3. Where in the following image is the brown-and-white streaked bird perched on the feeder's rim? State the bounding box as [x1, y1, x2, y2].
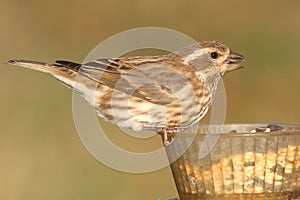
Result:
[8, 41, 245, 146]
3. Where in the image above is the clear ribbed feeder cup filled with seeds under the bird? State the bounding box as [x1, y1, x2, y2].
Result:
[166, 124, 300, 200]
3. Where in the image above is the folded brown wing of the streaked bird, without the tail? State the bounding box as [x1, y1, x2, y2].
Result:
[70, 56, 191, 105]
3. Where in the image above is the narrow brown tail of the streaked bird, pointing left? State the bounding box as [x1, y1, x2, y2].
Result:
[8, 59, 81, 87]
